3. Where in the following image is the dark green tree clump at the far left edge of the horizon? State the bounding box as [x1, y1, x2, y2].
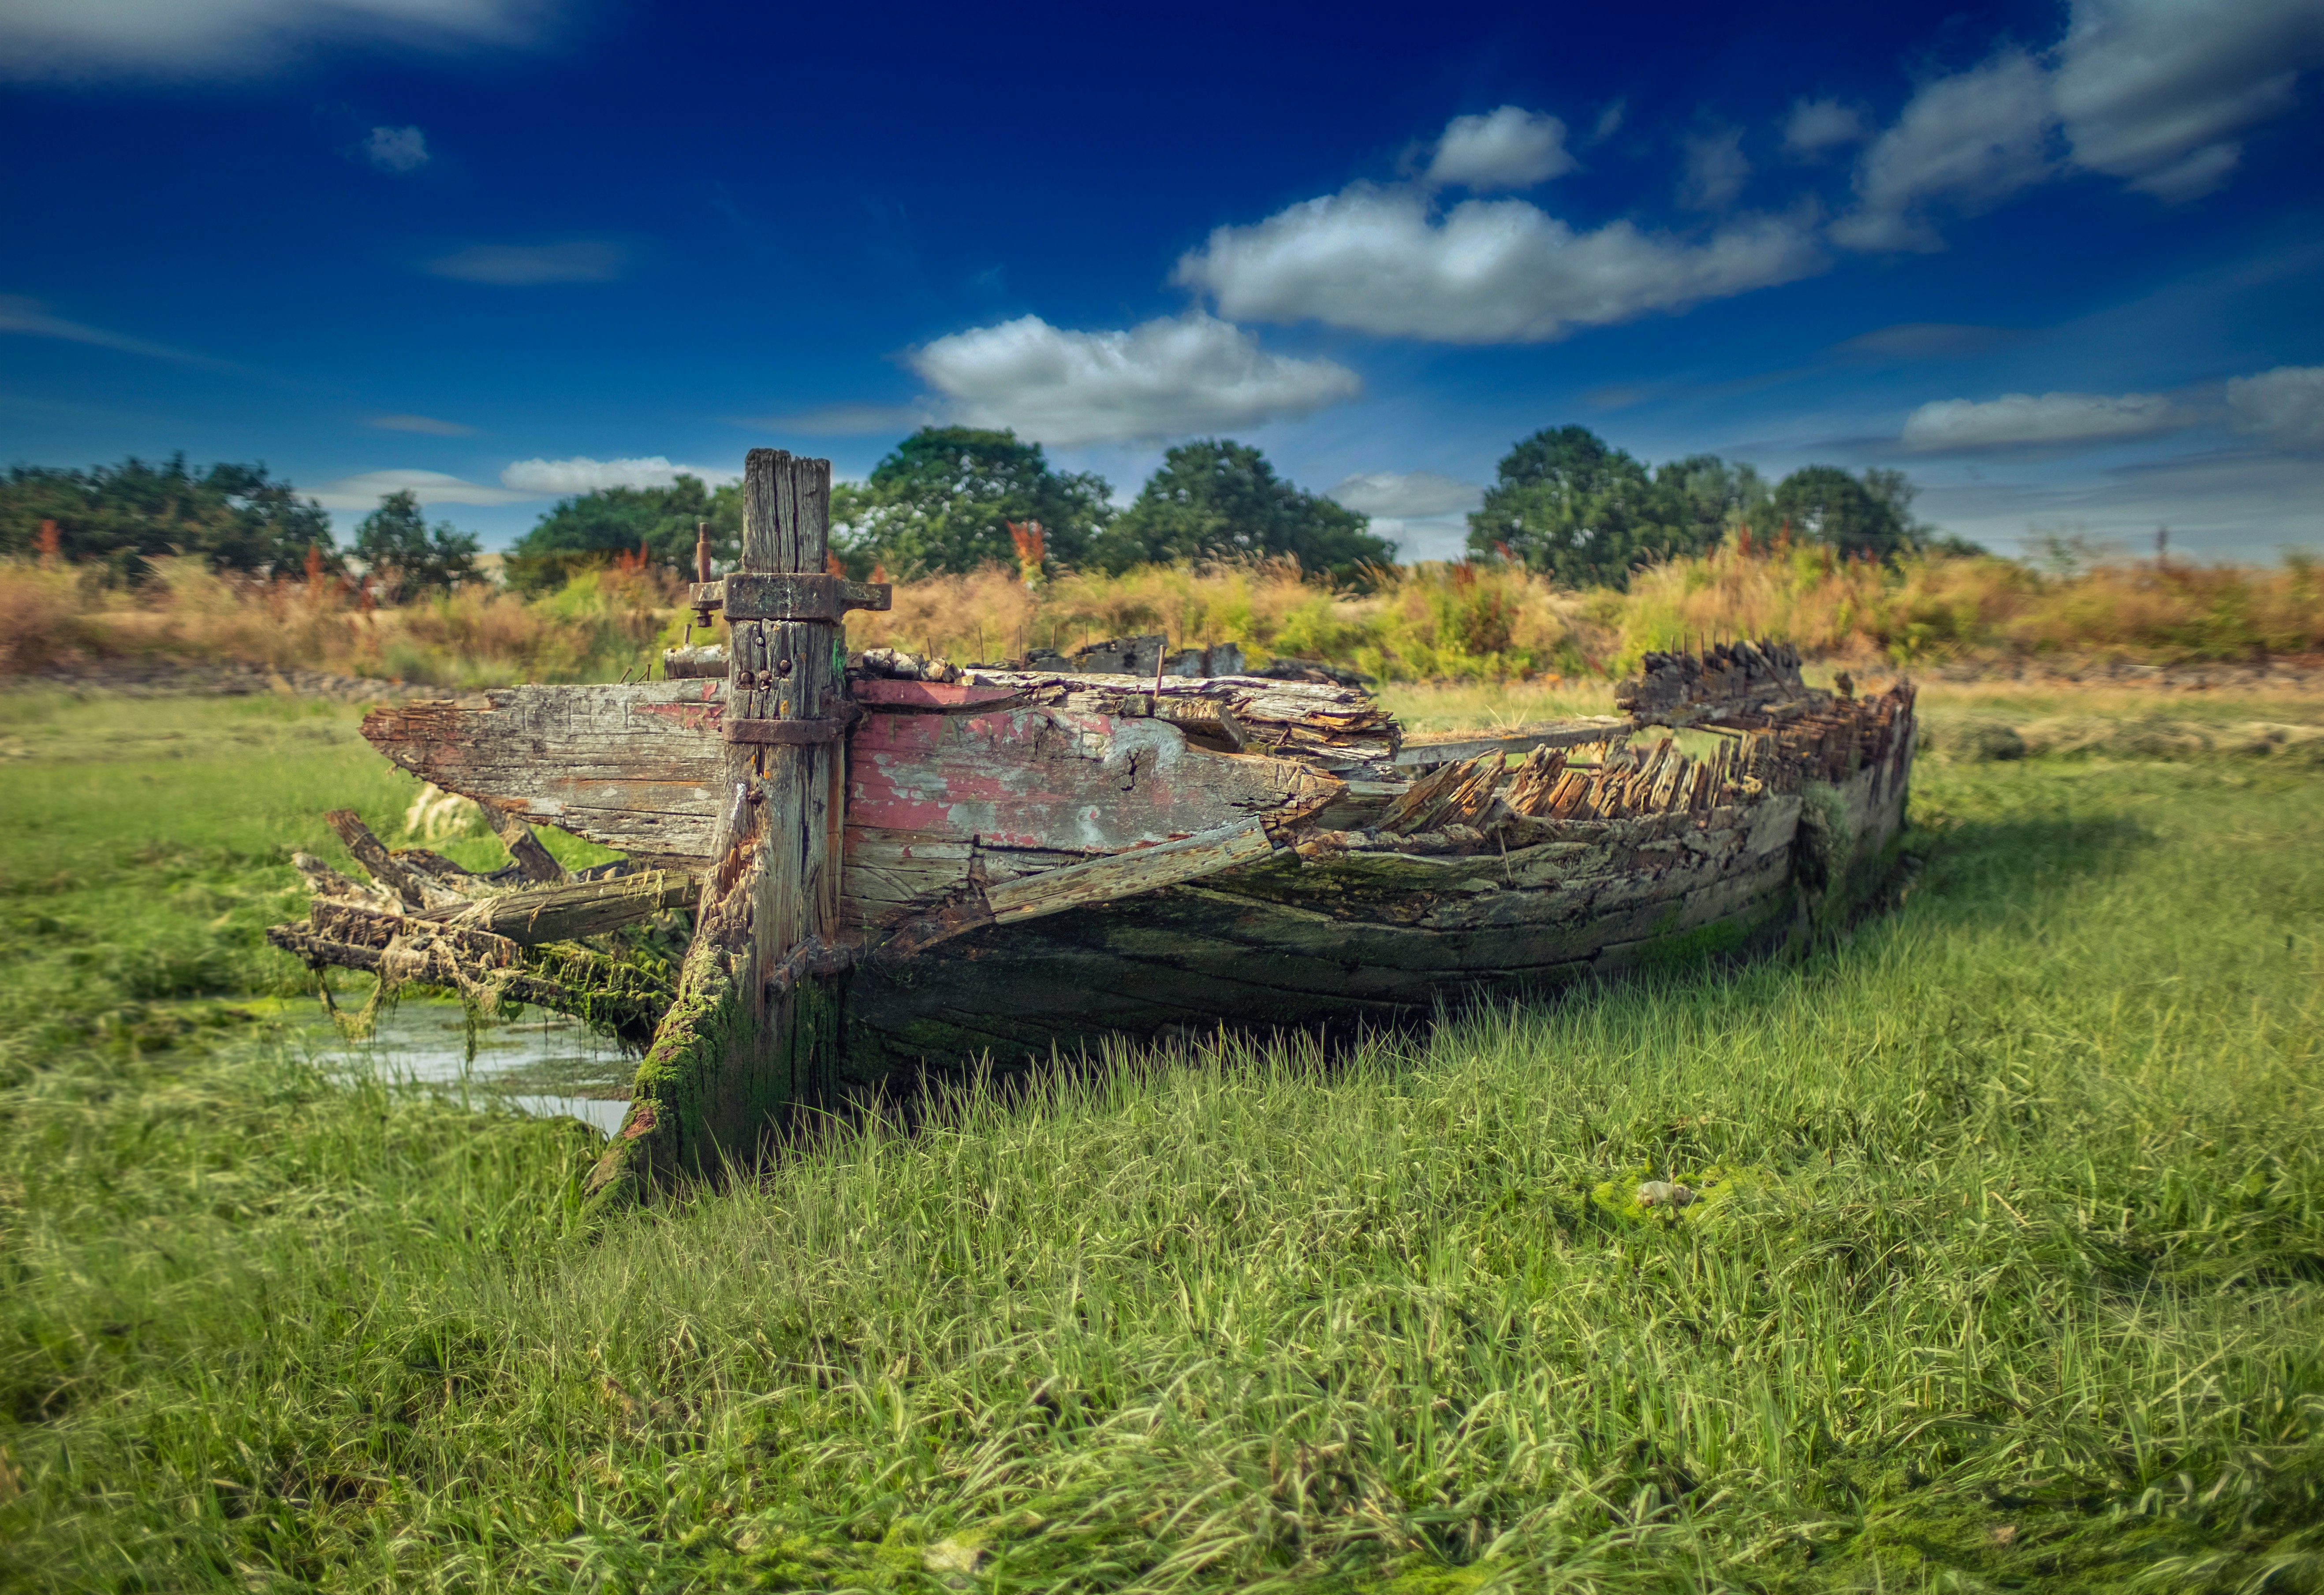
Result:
[0, 453, 339, 581]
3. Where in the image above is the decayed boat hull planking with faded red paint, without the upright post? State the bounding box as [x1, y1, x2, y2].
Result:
[299, 648, 1913, 1125]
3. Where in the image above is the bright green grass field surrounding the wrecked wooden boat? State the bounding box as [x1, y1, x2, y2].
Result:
[0, 688, 2324, 1595]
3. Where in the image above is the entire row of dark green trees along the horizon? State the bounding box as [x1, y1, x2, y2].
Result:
[0, 425, 1966, 602]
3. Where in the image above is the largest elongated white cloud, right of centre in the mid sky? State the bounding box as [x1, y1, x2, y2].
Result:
[1176, 184, 1824, 344]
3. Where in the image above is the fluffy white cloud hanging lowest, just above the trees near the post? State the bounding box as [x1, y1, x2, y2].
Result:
[911, 312, 1364, 447]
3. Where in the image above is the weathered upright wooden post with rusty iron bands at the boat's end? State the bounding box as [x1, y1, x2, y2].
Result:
[590, 449, 888, 1195]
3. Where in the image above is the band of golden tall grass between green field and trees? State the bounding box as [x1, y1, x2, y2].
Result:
[0, 540, 2324, 688]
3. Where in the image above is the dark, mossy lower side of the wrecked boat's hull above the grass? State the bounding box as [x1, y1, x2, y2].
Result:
[841, 732, 1913, 1086]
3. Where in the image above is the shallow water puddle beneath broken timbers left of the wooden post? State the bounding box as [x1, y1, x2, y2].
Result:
[316, 1000, 637, 1135]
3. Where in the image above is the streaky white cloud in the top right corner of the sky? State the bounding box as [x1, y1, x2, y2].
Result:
[2052, 0, 2324, 200]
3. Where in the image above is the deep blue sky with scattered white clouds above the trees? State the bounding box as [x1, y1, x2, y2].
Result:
[0, 0, 2324, 558]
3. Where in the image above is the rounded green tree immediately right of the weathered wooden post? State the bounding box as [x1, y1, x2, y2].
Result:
[832, 425, 1113, 577]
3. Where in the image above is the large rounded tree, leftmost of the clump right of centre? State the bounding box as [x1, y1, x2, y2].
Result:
[1469, 425, 1690, 586]
